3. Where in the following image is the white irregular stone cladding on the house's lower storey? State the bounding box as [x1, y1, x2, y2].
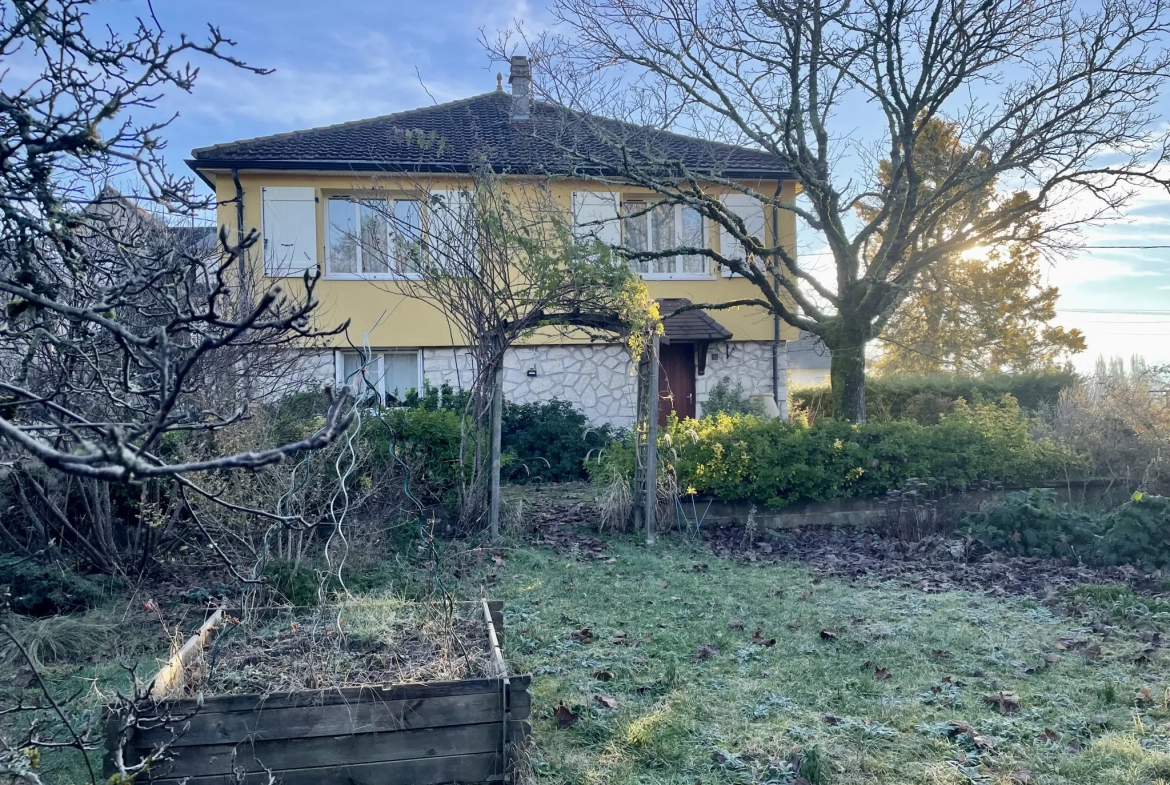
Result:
[293, 340, 787, 428]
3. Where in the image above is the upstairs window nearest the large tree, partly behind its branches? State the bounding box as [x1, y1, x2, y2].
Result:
[621, 200, 710, 278]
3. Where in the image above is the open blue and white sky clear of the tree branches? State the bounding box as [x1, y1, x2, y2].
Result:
[88, 0, 1170, 369]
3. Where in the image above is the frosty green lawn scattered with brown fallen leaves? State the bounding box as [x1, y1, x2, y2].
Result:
[466, 540, 1170, 785]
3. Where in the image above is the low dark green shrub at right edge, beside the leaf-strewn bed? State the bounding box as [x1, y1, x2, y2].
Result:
[964, 489, 1170, 570]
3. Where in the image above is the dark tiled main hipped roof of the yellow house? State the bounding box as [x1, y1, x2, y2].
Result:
[187, 90, 787, 179]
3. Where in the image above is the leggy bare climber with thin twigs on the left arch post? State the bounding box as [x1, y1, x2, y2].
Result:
[352, 164, 660, 536]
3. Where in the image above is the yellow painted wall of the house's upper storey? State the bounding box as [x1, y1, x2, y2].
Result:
[200, 170, 798, 349]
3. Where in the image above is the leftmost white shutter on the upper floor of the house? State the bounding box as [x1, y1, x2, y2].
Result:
[260, 187, 317, 277]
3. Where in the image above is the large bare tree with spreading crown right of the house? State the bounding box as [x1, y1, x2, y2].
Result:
[489, 0, 1170, 421]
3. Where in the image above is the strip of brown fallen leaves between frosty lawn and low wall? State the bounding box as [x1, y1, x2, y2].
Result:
[703, 526, 1162, 600]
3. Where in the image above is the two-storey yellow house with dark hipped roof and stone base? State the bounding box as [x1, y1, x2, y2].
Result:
[187, 57, 798, 426]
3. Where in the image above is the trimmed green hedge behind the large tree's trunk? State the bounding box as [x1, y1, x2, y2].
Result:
[789, 371, 1076, 425]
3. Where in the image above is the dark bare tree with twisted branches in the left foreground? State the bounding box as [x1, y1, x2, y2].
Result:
[0, 0, 349, 488]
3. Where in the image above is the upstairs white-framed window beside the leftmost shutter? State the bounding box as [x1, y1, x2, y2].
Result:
[326, 197, 422, 278]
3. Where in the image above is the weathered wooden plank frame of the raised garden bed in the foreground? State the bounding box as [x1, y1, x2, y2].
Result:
[105, 600, 531, 785]
